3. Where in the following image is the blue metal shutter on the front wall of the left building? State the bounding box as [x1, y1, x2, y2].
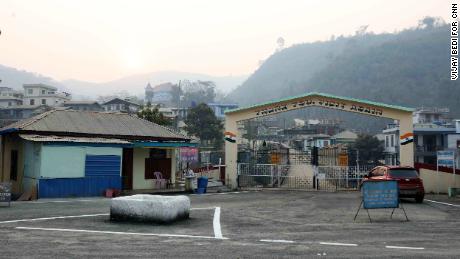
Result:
[85, 155, 121, 177]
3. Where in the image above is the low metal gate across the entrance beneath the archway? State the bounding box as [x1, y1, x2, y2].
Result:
[238, 163, 373, 191]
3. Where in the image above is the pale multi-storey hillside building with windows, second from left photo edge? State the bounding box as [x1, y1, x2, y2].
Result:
[23, 84, 72, 107]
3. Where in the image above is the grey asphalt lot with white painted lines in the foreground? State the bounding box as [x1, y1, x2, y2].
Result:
[0, 191, 460, 258]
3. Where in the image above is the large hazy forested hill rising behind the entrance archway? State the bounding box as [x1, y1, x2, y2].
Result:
[229, 20, 460, 120]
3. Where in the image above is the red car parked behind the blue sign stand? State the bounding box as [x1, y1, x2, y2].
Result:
[363, 165, 425, 203]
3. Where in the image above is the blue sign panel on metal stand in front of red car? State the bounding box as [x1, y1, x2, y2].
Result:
[362, 180, 399, 209]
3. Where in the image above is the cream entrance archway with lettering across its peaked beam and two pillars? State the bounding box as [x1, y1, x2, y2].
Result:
[225, 93, 414, 188]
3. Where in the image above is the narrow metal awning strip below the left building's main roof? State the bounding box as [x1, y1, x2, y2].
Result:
[19, 134, 131, 144]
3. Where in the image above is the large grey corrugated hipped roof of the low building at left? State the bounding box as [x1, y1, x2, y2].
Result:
[0, 110, 190, 140]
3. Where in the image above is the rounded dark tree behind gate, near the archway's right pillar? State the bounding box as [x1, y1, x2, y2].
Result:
[352, 134, 384, 164]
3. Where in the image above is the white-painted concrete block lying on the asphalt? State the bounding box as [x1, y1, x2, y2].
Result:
[110, 194, 190, 223]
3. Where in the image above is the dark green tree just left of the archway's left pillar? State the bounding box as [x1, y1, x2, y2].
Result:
[185, 103, 224, 148]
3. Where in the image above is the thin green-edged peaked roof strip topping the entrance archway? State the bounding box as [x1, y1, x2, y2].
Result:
[225, 92, 415, 114]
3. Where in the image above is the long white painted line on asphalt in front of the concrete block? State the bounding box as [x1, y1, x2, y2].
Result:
[16, 227, 228, 242]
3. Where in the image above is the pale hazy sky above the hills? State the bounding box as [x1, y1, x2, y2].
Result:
[0, 0, 451, 82]
